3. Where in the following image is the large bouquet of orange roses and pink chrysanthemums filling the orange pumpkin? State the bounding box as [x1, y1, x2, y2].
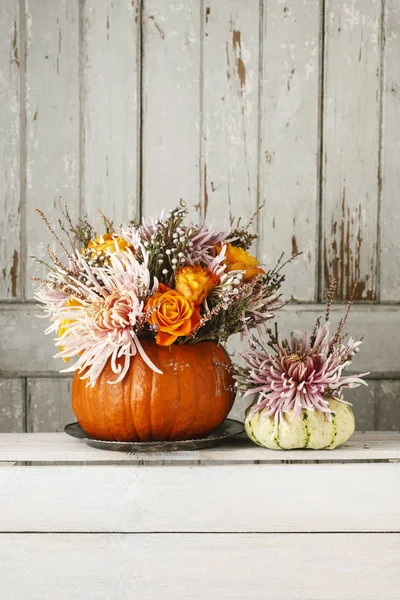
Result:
[35, 203, 284, 385]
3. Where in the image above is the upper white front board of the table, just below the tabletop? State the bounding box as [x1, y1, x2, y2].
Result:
[0, 462, 400, 533]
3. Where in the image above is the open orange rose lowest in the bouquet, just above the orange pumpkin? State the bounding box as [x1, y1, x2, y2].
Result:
[145, 284, 201, 346]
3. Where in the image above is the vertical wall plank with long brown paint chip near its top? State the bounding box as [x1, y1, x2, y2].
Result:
[201, 0, 260, 227]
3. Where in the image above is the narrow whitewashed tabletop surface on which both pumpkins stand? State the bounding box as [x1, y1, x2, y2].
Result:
[0, 431, 400, 466]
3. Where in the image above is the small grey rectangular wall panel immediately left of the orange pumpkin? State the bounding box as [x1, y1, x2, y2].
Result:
[27, 378, 76, 433]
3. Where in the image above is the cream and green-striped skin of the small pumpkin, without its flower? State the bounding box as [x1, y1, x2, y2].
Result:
[245, 398, 355, 450]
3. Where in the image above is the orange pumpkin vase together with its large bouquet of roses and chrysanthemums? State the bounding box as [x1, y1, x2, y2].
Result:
[35, 203, 283, 442]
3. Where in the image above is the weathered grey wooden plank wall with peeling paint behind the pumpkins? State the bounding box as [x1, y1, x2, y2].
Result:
[0, 0, 400, 431]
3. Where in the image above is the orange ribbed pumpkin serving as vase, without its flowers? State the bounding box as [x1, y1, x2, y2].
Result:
[72, 340, 235, 442]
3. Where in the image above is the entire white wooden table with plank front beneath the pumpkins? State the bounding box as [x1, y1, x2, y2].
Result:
[0, 432, 400, 600]
